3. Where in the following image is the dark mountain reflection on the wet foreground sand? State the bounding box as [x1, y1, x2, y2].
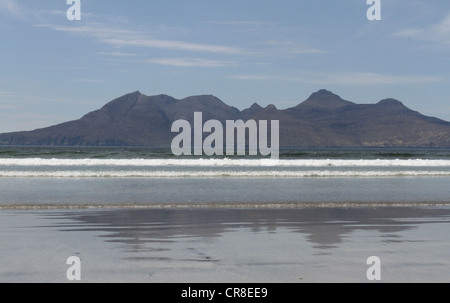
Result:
[46, 207, 450, 255]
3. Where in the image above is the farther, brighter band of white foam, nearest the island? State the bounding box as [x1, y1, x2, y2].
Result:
[0, 158, 450, 167]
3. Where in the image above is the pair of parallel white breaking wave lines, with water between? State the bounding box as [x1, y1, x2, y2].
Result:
[0, 158, 450, 178]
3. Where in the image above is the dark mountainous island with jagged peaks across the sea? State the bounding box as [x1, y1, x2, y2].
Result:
[0, 90, 450, 148]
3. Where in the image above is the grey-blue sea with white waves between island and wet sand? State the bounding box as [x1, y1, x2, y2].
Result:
[0, 147, 450, 209]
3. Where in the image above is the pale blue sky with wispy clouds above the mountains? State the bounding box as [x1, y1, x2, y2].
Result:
[0, 0, 450, 133]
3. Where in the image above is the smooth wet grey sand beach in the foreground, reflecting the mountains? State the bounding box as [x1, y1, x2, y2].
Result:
[0, 206, 450, 283]
